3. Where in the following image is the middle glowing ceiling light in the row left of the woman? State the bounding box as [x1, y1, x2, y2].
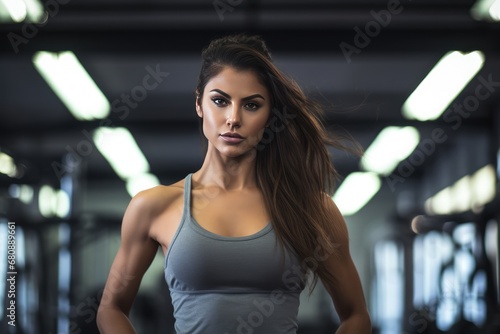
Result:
[93, 127, 149, 180]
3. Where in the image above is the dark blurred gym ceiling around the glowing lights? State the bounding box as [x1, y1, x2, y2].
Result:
[0, 0, 500, 217]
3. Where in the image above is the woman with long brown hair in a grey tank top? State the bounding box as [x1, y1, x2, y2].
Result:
[97, 35, 371, 334]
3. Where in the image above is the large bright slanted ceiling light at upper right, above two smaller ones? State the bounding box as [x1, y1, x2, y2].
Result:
[402, 51, 484, 121]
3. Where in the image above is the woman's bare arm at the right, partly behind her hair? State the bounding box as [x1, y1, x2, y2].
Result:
[323, 197, 372, 334]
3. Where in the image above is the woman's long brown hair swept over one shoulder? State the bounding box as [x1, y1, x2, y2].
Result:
[196, 34, 360, 289]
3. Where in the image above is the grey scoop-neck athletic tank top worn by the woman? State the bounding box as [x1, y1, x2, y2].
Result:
[165, 174, 305, 334]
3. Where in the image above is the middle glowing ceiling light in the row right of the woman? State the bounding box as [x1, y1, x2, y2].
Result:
[361, 126, 420, 175]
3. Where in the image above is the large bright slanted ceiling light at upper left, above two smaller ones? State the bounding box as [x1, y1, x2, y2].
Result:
[33, 51, 111, 120]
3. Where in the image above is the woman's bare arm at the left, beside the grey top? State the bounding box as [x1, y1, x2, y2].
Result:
[97, 191, 158, 334]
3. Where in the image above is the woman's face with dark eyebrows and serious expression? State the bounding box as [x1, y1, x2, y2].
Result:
[196, 67, 271, 157]
